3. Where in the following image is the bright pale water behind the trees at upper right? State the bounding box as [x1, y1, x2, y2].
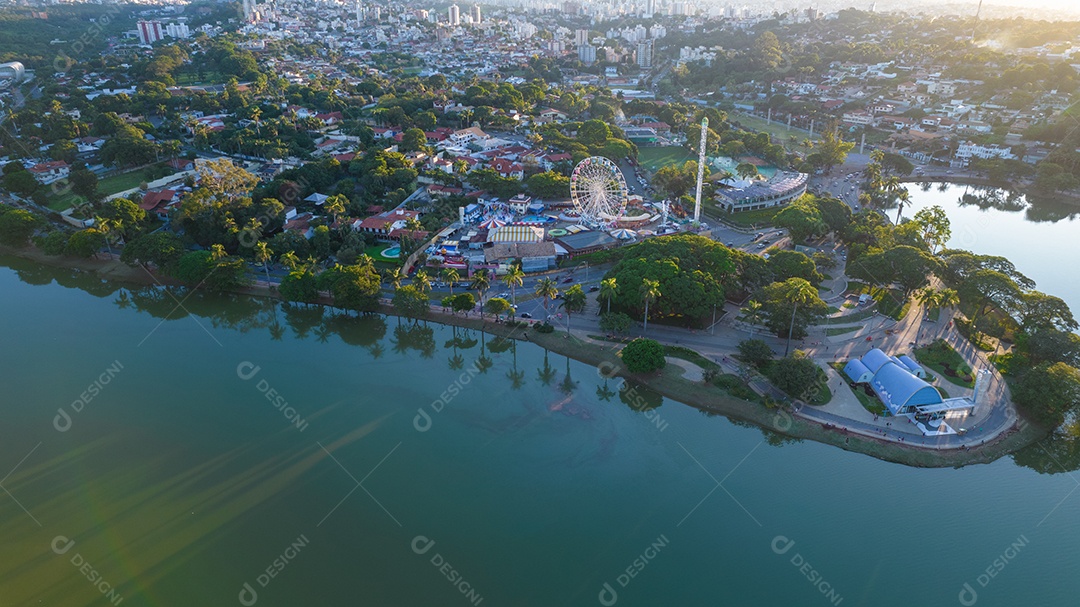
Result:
[890, 184, 1080, 312]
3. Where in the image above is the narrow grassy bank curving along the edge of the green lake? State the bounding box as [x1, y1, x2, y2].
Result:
[0, 241, 1045, 468]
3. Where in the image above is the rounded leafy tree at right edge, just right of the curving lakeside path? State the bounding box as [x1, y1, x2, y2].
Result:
[1012, 363, 1080, 428]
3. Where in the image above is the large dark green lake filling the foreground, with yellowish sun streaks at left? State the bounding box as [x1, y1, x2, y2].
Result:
[0, 258, 1080, 607]
